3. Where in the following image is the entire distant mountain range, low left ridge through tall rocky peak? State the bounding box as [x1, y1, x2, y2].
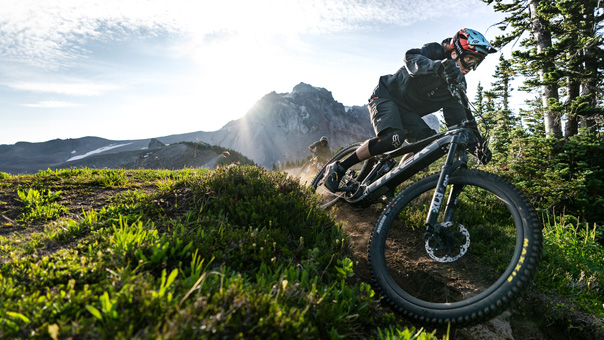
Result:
[0, 83, 438, 174]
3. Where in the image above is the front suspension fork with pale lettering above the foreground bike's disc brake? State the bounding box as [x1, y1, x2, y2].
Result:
[426, 136, 463, 229]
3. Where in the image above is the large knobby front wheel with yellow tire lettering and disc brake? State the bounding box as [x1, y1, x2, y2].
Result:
[369, 169, 542, 326]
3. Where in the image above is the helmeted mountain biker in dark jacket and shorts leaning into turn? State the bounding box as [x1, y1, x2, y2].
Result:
[324, 28, 497, 192]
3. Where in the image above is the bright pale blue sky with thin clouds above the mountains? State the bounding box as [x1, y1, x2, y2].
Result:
[0, 0, 520, 144]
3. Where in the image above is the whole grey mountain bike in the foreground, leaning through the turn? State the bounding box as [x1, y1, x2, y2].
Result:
[311, 80, 543, 326]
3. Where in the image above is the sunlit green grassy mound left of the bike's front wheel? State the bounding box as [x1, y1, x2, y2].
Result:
[0, 166, 444, 339]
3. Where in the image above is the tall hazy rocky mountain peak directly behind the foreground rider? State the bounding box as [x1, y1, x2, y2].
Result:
[189, 83, 373, 168]
